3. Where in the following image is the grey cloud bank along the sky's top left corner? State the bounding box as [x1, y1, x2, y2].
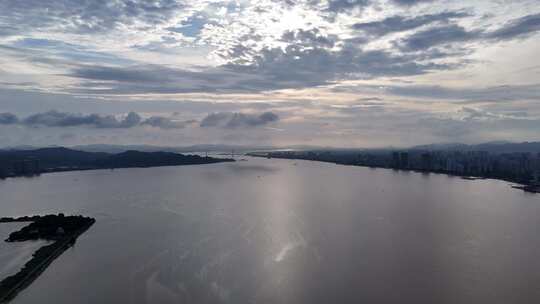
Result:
[0, 0, 184, 33]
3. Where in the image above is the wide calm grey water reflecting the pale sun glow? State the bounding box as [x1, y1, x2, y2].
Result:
[0, 158, 540, 304]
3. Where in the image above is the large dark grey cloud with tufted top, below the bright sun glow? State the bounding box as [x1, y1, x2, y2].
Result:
[216, 29, 460, 90]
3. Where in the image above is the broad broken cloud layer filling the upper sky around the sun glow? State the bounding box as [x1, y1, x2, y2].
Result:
[0, 0, 538, 95]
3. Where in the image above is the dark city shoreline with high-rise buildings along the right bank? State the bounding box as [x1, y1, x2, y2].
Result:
[267, 150, 540, 187]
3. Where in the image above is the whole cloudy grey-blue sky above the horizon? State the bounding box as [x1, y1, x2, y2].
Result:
[0, 0, 540, 147]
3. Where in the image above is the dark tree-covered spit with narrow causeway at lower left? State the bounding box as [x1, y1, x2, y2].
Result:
[0, 213, 96, 303]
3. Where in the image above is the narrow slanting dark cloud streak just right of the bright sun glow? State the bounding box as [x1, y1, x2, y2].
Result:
[352, 12, 470, 36]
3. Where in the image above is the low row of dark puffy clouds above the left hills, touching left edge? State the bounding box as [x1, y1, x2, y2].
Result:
[0, 111, 184, 129]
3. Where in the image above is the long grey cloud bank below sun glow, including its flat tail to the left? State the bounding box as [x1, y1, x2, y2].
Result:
[67, 38, 453, 94]
